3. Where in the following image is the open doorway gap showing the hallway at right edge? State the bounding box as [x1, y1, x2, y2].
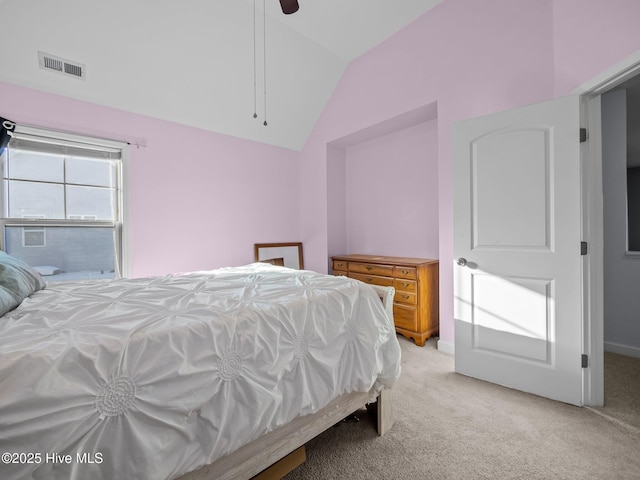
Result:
[601, 75, 640, 428]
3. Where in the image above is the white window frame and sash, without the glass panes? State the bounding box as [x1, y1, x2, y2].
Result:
[0, 125, 129, 278]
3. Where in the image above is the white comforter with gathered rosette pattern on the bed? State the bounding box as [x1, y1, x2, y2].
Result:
[0, 264, 400, 480]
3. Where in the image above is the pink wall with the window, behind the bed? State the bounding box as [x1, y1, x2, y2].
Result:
[0, 82, 300, 276]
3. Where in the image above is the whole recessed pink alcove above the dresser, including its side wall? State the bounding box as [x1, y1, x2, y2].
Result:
[327, 102, 438, 270]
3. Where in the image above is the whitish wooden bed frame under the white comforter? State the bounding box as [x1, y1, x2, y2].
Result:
[178, 285, 395, 480]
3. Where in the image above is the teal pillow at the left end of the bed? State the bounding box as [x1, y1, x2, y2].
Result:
[0, 251, 46, 315]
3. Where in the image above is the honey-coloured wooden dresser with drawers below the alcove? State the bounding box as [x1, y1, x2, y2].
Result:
[331, 255, 439, 346]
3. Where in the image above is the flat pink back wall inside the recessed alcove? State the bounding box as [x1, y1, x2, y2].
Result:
[342, 120, 439, 258]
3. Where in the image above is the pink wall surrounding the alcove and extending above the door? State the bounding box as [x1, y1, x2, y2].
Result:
[301, 0, 640, 345]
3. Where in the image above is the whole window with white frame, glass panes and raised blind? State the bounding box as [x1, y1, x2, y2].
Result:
[0, 126, 127, 281]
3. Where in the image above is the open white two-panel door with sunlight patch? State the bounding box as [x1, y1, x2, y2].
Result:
[453, 96, 582, 405]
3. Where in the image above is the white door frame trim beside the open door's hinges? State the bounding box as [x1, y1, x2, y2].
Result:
[572, 50, 640, 406]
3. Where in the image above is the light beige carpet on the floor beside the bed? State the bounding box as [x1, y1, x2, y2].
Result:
[284, 337, 640, 480]
